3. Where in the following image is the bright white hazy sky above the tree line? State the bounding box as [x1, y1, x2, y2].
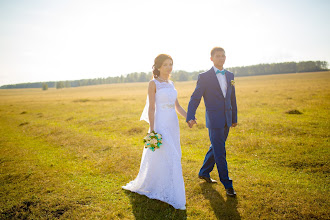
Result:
[0, 0, 330, 86]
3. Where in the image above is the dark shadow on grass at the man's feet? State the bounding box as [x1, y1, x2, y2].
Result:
[200, 182, 241, 220]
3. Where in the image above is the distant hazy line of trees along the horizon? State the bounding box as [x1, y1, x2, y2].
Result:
[0, 61, 328, 90]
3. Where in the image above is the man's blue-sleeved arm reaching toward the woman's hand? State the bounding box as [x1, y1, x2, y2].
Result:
[186, 74, 205, 122]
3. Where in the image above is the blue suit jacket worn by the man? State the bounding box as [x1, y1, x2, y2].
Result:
[187, 67, 237, 128]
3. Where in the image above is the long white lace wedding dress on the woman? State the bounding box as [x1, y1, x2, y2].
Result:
[123, 79, 186, 210]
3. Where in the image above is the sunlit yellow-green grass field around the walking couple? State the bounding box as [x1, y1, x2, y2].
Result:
[0, 72, 330, 219]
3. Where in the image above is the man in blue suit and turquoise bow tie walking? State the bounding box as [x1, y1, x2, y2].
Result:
[187, 47, 237, 196]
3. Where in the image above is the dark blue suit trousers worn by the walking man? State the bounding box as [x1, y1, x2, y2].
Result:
[199, 126, 233, 189]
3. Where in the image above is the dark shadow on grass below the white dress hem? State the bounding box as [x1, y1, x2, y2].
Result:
[124, 190, 187, 220]
